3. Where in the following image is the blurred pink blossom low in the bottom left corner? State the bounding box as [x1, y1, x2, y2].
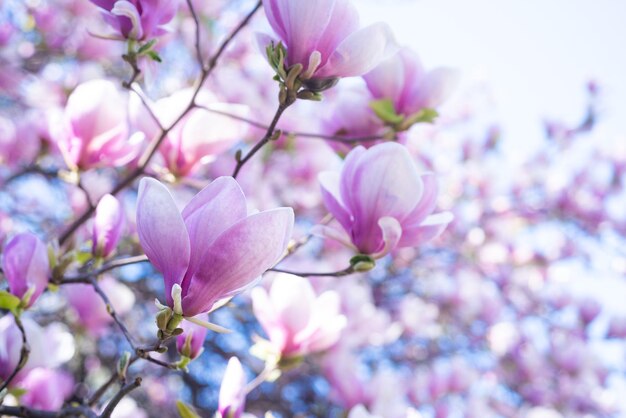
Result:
[17, 367, 74, 411]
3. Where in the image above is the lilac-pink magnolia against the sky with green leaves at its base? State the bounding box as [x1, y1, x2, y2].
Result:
[363, 47, 457, 116]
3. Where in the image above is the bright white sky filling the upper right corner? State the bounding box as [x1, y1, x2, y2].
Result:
[357, 0, 626, 159]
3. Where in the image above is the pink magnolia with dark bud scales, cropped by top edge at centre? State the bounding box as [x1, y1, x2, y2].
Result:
[263, 0, 395, 88]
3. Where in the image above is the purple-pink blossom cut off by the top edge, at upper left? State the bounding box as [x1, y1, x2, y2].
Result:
[91, 0, 180, 41]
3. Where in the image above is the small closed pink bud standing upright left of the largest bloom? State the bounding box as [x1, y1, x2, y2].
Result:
[92, 194, 124, 257]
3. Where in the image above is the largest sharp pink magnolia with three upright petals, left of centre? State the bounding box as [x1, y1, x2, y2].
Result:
[137, 177, 294, 320]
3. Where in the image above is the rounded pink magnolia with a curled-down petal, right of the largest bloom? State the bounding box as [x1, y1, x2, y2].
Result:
[319, 142, 452, 258]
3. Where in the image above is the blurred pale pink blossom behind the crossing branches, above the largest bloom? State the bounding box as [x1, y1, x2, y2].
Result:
[131, 89, 248, 177]
